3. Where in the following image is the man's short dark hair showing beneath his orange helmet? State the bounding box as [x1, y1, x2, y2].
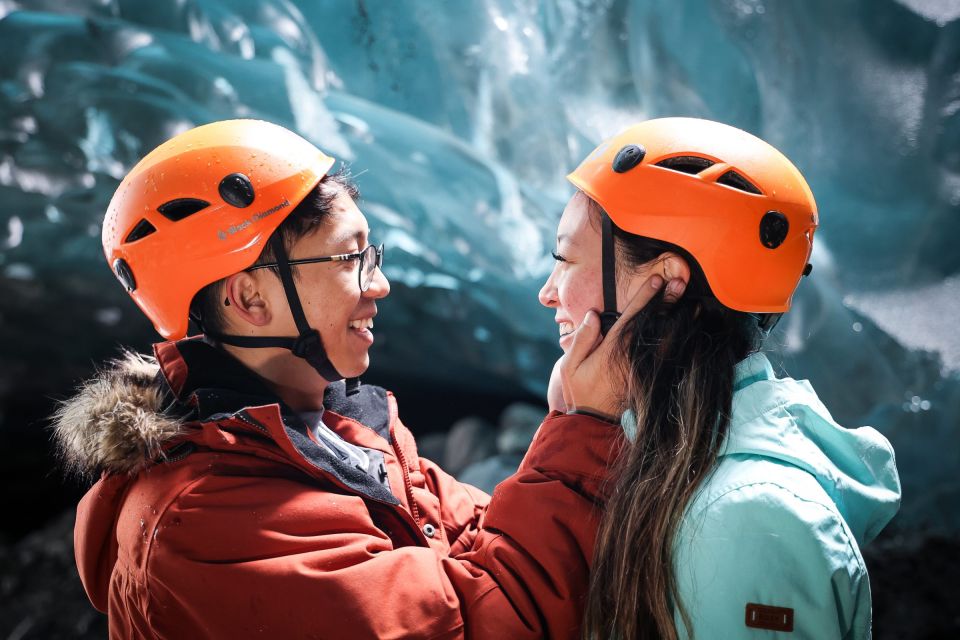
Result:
[190, 168, 360, 334]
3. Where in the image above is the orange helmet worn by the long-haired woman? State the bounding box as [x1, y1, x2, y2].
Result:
[567, 118, 818, 314]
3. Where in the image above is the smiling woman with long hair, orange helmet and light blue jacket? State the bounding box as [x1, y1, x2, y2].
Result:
[540, 118, 900, 640]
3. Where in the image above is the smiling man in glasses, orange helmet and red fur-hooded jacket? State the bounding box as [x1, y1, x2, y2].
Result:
[56, 120, 653, 639]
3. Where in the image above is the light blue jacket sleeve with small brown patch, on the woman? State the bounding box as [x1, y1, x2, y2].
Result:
[674, 482, 871, 640]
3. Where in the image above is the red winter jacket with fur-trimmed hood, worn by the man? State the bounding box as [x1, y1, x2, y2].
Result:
[57, 339, 620, 639]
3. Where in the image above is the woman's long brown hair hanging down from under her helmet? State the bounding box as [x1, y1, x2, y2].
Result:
[584, 202, 760, 640]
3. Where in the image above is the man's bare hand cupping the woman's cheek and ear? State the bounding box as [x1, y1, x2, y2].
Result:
[560, 275, 663, 422]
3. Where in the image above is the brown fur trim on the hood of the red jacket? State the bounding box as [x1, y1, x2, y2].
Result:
[52, 351, 183, 478]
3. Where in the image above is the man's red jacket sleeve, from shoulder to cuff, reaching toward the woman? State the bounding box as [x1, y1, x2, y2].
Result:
[146, 414, 620, 639]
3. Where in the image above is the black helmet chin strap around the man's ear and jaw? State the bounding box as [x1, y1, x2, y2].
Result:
[206, 234, 360, 395]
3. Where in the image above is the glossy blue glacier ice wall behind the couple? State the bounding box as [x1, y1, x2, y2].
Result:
[0, 0, 960, 531]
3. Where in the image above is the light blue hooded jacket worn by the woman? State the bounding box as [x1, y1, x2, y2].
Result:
[628, 353, 900, 640]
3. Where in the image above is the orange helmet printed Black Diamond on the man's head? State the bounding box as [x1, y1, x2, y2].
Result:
[103, 120, 334, 339]
